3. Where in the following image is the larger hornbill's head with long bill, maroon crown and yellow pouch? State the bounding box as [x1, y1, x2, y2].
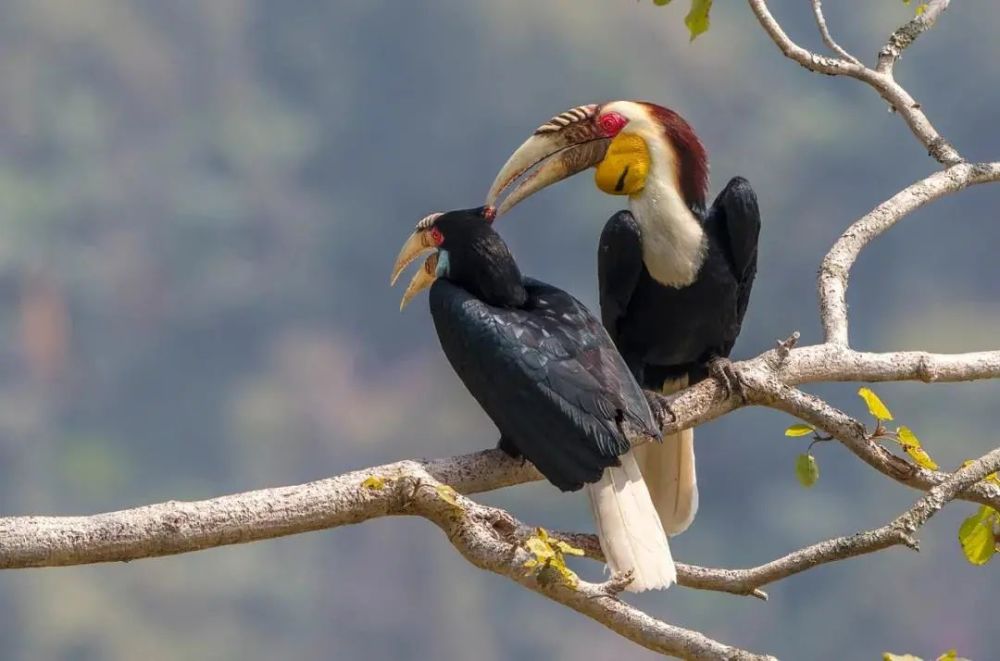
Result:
[486, 101, 708, 216]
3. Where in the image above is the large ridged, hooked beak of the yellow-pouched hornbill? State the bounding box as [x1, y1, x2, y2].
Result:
[486, 105, 611, 217]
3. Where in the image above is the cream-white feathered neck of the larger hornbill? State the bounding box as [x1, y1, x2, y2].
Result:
[629, 160, 708, 287]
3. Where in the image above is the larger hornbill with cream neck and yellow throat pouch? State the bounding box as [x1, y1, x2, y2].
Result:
[486, 101, 760, 534]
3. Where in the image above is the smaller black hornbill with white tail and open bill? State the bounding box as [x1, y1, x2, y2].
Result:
[392, 207, 675, 592]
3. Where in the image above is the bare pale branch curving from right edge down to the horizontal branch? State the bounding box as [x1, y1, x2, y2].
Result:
[818, 162, 1000, 345]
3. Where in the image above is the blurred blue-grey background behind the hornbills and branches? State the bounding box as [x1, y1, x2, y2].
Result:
[0, 0, 1000, 661]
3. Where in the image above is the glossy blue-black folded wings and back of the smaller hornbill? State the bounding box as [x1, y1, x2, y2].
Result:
[430, 280, 659, 491]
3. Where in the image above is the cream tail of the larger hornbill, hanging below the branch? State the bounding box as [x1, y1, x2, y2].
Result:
[633, 376, 698, 536]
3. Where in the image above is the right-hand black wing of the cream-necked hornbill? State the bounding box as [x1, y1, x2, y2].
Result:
[705, 177, 760, 338]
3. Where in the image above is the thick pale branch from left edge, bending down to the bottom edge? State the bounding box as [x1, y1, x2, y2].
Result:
[0, 451, 771, 661]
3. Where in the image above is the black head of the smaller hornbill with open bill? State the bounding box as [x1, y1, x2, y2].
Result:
[390, 207, 523, 310]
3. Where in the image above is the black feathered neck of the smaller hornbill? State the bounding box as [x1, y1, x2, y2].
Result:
[448, 231, 528, 308]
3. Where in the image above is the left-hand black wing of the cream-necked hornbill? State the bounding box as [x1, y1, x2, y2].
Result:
[597, 211, 642, 349]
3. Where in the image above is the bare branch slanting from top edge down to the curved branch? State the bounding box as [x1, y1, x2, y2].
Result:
[747, 0, 963, 165]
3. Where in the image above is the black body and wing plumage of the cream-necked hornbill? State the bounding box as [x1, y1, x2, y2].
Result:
[598, 177, 760, 390]
